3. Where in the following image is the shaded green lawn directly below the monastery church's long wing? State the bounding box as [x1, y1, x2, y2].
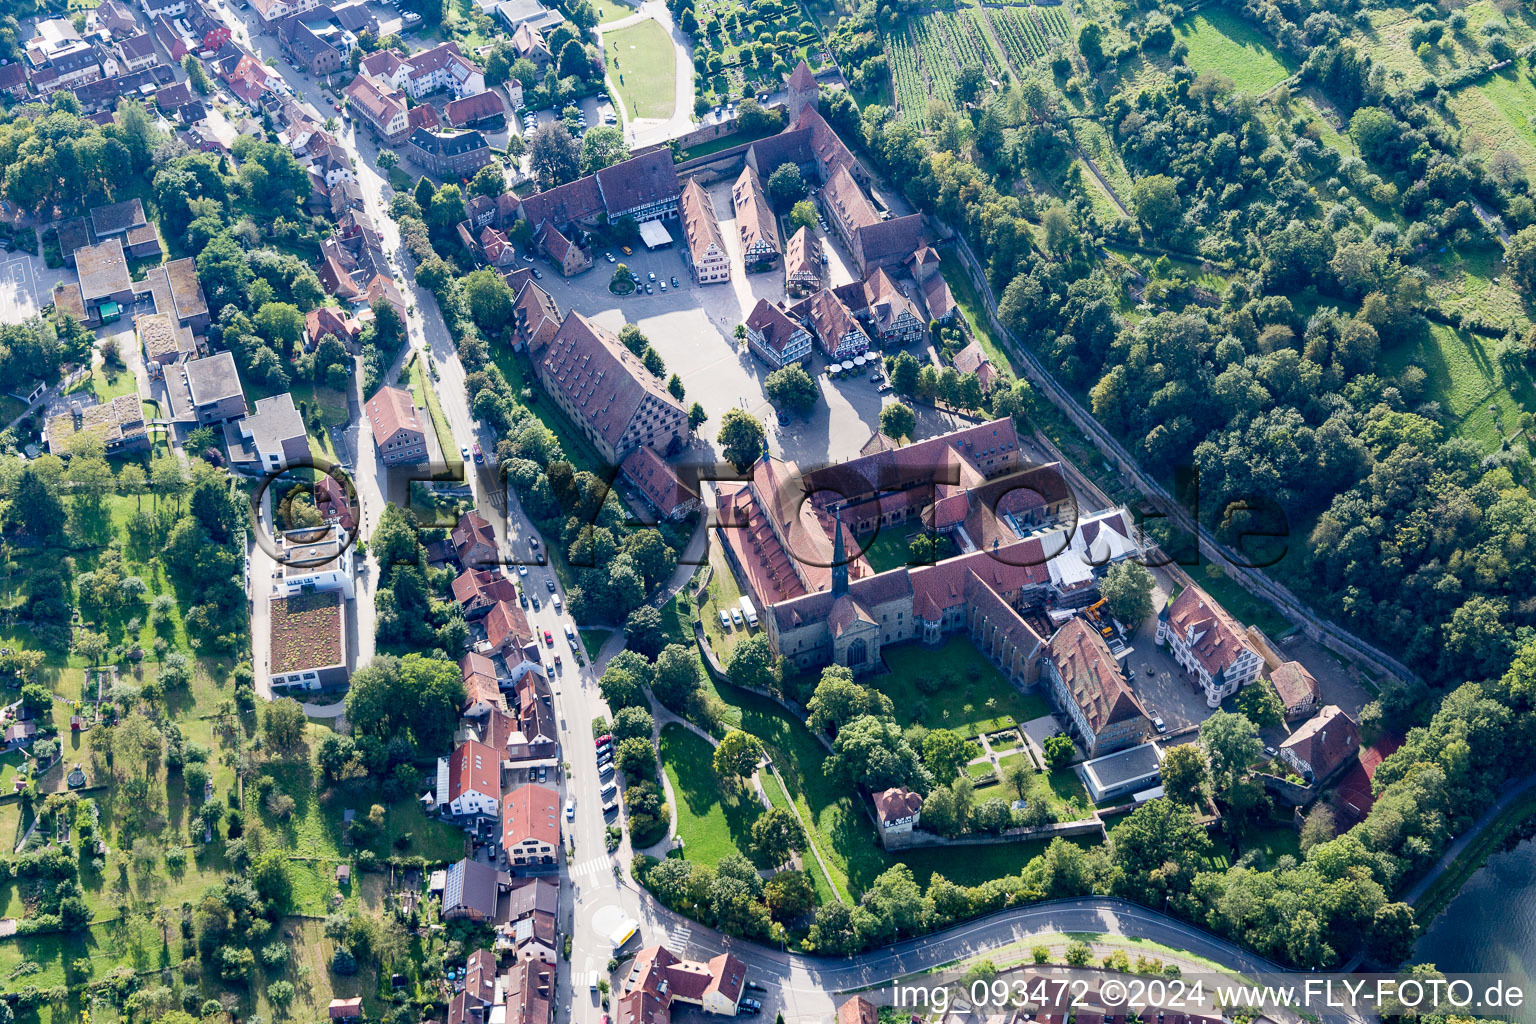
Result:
[871, 636, 1051, 735]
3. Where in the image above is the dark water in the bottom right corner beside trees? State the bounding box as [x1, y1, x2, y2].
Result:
[1413, 840, 1536, 1024]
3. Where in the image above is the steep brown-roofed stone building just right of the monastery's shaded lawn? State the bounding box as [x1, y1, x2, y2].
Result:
[1041, 616, 1152, 757]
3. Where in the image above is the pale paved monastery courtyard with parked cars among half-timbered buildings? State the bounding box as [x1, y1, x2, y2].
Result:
[522, 181, 962, 467]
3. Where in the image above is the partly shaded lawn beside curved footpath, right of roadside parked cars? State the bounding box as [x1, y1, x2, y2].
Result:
[660, 723, 762, 866]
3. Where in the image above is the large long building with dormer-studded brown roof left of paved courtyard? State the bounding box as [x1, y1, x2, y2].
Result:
[528, 312, 688, 465]
